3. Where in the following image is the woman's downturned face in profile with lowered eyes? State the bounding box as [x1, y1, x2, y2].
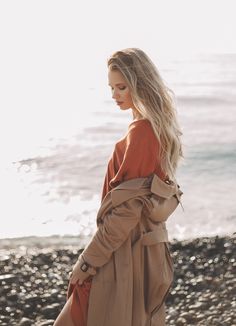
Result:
[108, 69, 135, 110]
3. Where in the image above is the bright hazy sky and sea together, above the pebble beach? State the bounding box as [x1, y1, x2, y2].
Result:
[0, 0, 236, 240]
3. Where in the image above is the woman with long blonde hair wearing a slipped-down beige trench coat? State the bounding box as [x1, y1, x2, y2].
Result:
[54, 48, 183, 326]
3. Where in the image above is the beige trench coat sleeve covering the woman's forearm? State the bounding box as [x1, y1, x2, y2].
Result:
[82, 197, 143, 268]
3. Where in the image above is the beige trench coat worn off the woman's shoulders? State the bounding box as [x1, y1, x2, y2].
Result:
[82, 174, 176, 326]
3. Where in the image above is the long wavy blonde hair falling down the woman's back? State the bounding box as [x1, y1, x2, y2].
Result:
[107, 48, 184, 181]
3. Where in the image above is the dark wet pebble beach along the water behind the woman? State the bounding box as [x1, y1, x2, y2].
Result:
[0, 232, 236, 326]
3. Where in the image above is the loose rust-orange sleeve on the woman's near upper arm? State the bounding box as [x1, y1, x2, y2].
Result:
[110, 121, 159, 188]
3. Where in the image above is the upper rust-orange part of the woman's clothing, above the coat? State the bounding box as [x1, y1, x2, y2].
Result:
[102, 119, 165, 200]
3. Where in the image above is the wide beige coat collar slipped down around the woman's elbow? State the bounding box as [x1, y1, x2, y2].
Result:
[111, 173, 178, 207]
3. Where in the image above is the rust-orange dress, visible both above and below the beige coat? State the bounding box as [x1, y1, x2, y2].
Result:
[67, 119, 166, 326]
